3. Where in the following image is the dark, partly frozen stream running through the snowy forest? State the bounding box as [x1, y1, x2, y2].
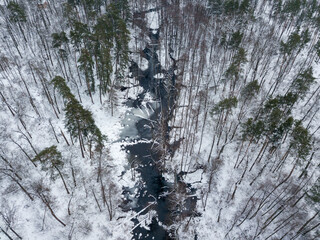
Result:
[122, 29, 176, 240]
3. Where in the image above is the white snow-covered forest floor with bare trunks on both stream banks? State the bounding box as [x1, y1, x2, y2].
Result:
[0, 0, 320, 240]
